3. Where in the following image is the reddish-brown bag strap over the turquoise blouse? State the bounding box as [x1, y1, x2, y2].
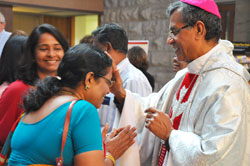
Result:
[56, 100, 77, 166]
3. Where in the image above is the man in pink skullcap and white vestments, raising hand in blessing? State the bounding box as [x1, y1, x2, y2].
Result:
[111, 0, 250, 166]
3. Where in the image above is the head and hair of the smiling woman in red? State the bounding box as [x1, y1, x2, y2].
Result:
[18, 24, 69, 85]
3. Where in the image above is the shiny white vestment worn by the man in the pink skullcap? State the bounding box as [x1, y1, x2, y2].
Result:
[122, 42, 250, 166]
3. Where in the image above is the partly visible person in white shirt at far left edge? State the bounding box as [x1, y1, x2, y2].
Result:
[0, 12, 11, 58]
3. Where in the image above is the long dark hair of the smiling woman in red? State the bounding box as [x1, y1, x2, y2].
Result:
[17, 24, 69, 85]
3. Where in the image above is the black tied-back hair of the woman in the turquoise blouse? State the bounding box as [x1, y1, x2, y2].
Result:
[23, 44, 112, 113]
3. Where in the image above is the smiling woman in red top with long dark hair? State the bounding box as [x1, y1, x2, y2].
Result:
[0, 24, 69, 152]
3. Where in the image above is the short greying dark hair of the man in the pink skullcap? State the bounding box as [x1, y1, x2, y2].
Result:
[167, 1, 222, 42]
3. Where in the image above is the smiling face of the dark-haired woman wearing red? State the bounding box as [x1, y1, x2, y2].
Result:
[35, 32, 64, 78]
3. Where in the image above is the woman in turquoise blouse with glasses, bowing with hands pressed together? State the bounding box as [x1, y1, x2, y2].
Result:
[8, 44, 136, 166]
